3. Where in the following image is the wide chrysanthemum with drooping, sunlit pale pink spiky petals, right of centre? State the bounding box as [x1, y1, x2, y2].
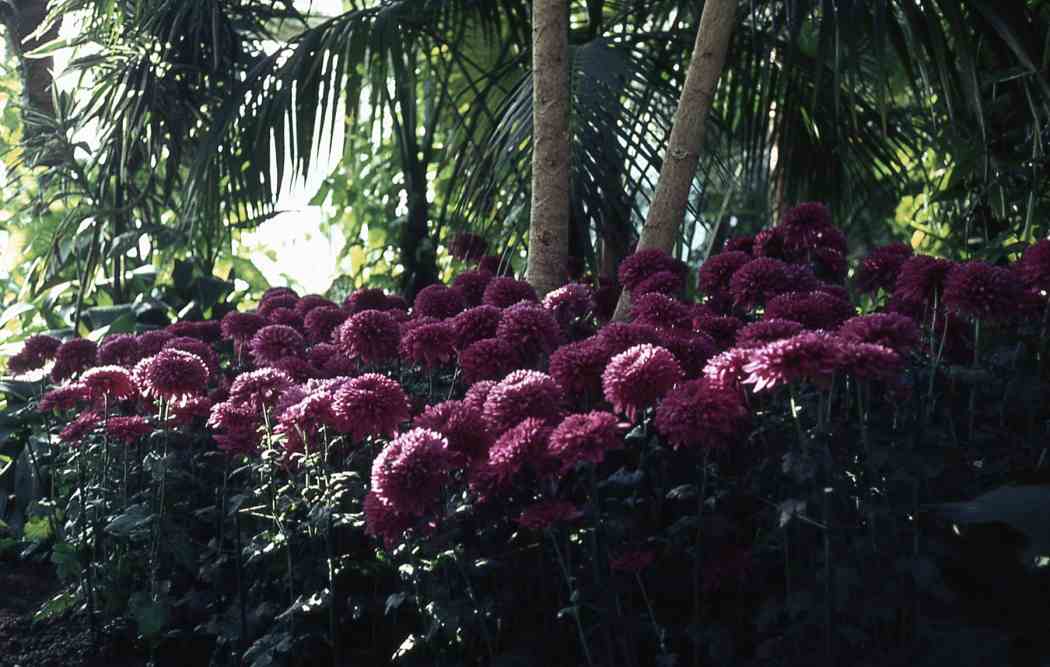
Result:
[743, 332, 843, 392]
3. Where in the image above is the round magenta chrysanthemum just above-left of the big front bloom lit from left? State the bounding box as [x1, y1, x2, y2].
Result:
[332, 373, 408, 442]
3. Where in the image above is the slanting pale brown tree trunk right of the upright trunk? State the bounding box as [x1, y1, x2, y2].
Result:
[615, 0, 736, 319]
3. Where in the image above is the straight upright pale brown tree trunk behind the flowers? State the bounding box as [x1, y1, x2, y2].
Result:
[525, 0, 569, 295]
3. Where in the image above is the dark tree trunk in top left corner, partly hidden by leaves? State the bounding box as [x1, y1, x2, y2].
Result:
[0, 0, 61, 165]
